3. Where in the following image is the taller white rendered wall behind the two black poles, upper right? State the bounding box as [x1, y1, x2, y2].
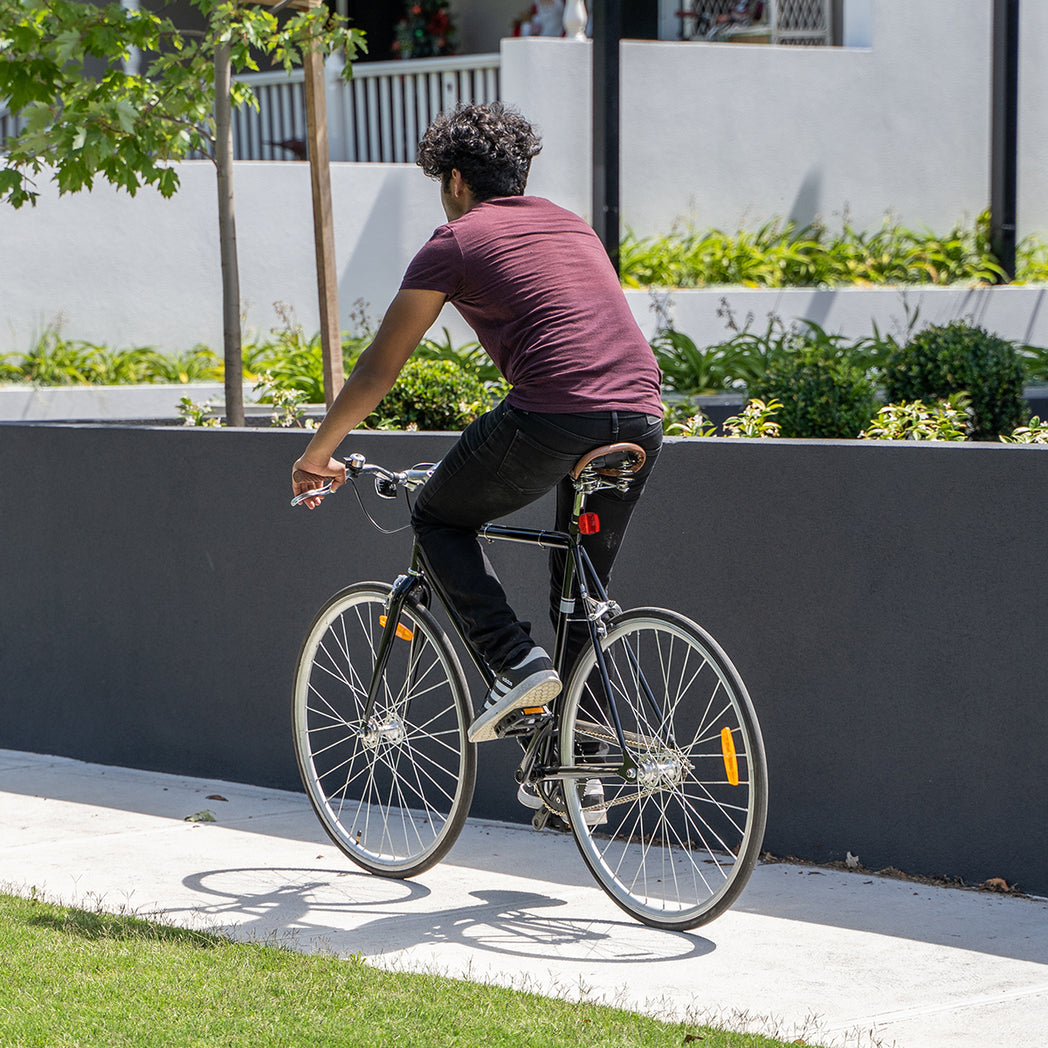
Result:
[502, 0, 1048, 235]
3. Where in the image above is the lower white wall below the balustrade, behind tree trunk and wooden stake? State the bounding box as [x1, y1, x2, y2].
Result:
[0, 161, 444, 352]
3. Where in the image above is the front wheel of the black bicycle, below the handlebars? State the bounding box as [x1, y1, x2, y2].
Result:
[293, 583, 477, 877]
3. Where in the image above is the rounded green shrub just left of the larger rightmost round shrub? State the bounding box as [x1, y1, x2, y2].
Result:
[750, 346, 874, 438]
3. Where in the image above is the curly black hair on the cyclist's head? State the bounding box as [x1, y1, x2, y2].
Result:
[415, 102, 542, 200]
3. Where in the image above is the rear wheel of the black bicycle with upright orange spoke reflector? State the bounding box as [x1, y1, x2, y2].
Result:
[561, 608, 768, 930]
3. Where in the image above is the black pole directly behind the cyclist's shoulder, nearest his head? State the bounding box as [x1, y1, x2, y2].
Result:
[592, 0, 623, 271]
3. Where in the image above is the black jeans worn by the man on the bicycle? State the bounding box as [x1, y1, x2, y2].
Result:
[412, 401, 662, 673]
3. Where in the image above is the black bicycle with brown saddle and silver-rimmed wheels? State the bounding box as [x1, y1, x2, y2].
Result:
[292, 443, 767, 930]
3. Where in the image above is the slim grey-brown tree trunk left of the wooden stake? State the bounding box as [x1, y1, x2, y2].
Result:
[215, 44, 244, 425]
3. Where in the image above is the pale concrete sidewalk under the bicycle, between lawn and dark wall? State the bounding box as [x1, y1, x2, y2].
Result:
[0, 750, 1048, 1048]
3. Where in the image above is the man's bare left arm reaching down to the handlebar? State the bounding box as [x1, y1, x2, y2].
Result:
[291, 289, 445, 509]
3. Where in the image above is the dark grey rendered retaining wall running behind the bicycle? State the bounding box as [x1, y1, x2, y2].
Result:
[0, 424, 1048, 893]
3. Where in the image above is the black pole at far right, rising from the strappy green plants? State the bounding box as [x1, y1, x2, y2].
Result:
[989, 0, 1019, 282]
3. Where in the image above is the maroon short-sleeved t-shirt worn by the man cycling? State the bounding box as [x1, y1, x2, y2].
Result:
[400, 197, 662, 415]
